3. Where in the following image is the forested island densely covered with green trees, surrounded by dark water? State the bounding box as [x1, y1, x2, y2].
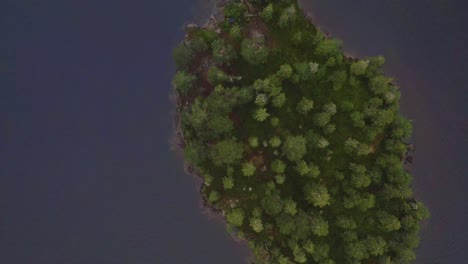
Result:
[173, 0, 429, 264]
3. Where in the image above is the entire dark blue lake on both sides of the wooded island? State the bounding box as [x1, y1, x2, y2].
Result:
[0, 0, 468, 264]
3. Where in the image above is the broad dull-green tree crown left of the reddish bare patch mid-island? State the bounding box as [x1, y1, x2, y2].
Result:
[210, 139, 244, 166]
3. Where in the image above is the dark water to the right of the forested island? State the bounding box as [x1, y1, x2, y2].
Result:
[301, 0, 468, 264]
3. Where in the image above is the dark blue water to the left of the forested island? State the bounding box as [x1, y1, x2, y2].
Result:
[0, 0, 247, 264]
